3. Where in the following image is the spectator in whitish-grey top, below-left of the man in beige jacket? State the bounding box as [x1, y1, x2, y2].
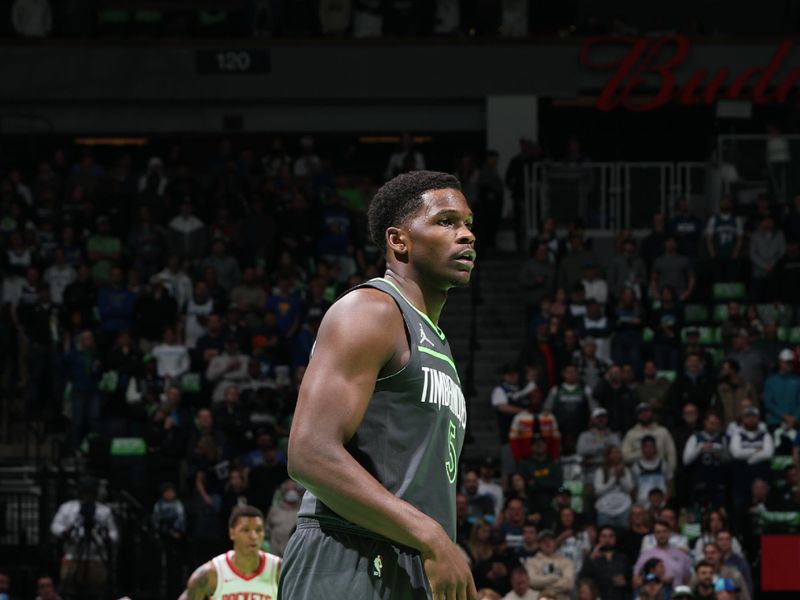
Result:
[592, 446, 634, 530]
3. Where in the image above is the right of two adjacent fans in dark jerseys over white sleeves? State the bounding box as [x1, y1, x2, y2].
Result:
[729, 406, 775, 510]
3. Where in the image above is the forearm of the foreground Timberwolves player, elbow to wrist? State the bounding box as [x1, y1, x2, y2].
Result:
[289, 436, 447, 553]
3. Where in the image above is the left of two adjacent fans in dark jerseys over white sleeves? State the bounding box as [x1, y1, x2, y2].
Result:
[683, 412, 729, 506]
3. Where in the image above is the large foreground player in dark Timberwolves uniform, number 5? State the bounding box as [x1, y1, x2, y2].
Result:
[279, 171, 477, 600]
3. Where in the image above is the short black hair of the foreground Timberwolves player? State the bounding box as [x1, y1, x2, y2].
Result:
[367, 171, 461, 252]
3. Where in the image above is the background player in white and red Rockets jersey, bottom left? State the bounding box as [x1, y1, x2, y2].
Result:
[178, 506, 281, 600]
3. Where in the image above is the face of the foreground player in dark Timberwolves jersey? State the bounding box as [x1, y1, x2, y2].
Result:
[405, 189, 475, 289]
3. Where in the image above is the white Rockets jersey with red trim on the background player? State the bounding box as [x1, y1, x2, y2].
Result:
[211, 550, 283, 600]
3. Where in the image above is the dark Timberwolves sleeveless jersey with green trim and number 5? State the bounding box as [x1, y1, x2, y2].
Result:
[298, 278, 467, 541]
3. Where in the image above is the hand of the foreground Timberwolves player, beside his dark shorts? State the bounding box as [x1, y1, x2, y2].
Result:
[422, 532, 478, 600]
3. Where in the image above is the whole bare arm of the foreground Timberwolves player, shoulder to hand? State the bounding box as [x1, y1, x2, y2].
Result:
[289, 290, 475, 600]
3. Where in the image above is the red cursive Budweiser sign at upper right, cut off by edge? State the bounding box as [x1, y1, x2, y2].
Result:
[580, 35, 800, 111]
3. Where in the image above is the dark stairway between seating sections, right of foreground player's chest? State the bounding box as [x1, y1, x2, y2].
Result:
[441, 255, 525, 464]
